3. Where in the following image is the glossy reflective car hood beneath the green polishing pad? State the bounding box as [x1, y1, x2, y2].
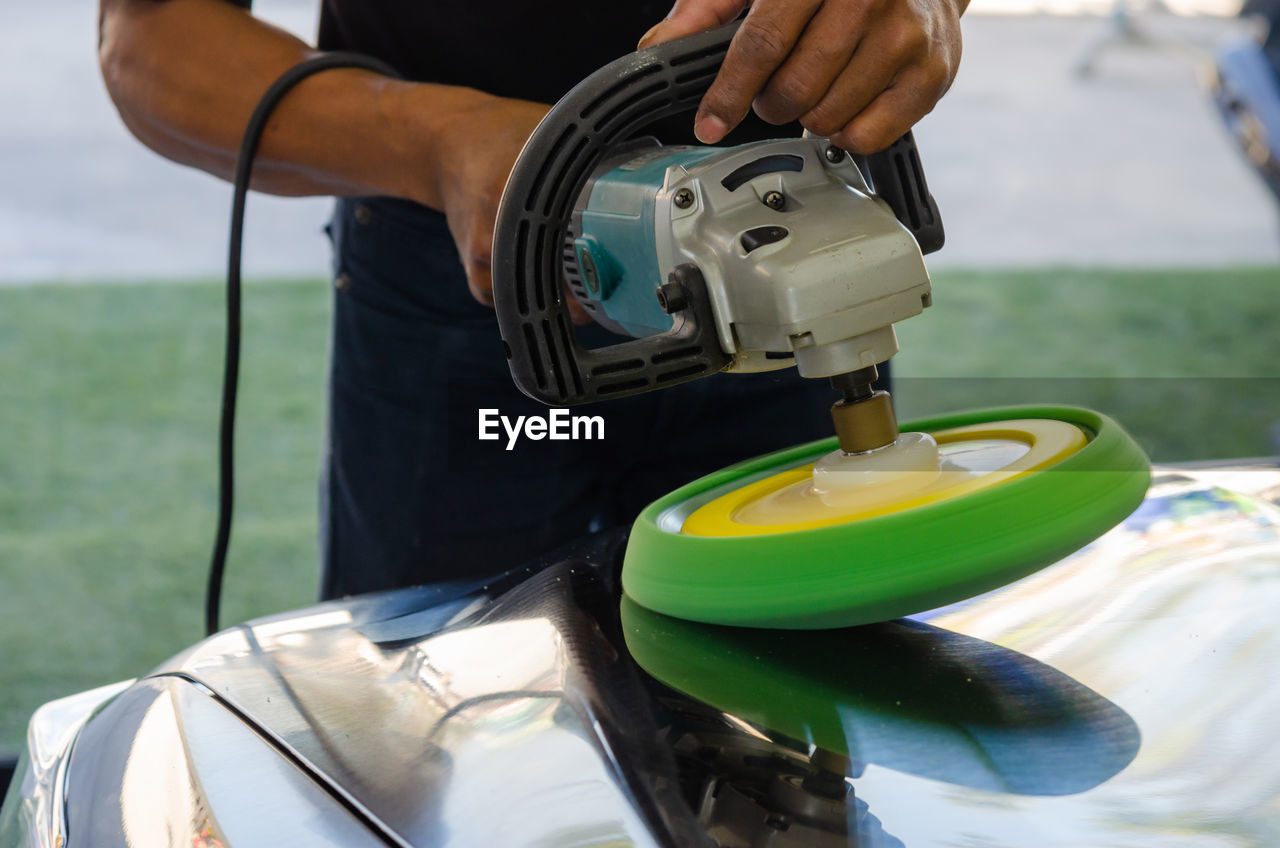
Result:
[45, 469, 1280, 848]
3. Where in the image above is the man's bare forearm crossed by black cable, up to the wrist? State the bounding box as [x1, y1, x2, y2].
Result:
[99, 0, 488, 208]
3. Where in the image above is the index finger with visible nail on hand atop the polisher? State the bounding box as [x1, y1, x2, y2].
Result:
[694, 0, 822, 145]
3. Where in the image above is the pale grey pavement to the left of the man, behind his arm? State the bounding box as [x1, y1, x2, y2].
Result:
[0, 0, 332, 283]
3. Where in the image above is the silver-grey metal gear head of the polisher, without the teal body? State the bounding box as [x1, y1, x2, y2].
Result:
[654, 138, 931, 378]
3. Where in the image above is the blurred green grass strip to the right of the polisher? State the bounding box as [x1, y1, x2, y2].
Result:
[893, 268, 1280, 461]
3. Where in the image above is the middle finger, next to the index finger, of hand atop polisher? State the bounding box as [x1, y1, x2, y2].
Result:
[755, 0, 873, 124]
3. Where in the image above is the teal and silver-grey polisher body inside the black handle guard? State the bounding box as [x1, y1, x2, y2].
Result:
[564, 138, 931, 377]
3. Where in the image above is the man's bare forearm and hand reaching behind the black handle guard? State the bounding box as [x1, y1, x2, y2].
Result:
[99, 0, 589, 323]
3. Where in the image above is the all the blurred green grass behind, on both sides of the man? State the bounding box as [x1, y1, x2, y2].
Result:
[0, 268, 1280, 749]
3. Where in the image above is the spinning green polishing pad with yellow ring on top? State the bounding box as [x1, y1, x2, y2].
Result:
[622, 406, 1149, 629]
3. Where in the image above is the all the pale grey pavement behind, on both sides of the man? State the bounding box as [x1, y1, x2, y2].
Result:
[0, 0, 1280, 283]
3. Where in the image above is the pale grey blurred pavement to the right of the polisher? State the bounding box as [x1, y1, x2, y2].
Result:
[916, 15, 1280, 268]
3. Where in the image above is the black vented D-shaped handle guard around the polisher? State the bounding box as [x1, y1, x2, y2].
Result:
[493, 22, 942, 406]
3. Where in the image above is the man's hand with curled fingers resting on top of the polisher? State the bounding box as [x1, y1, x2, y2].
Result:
[640, 0, 968, 154]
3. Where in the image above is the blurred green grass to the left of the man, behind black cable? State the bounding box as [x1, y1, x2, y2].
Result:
[0, 282, 328, 749]
